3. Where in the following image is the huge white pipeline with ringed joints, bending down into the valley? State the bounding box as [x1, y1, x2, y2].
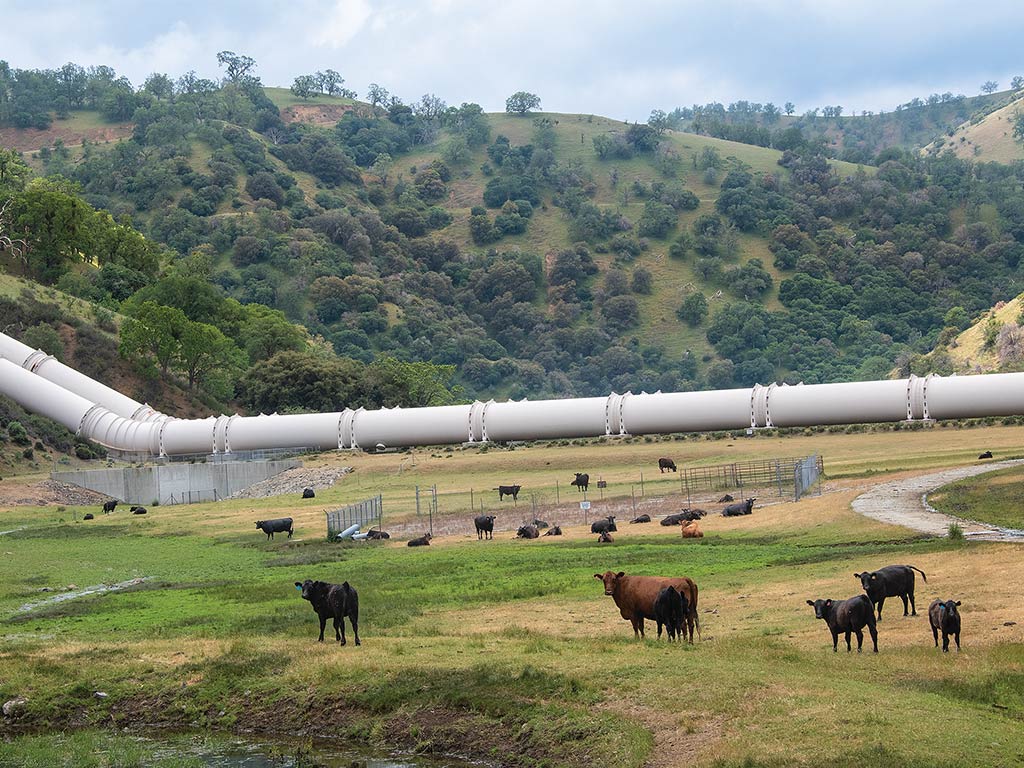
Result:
[0, 334, 1024, 458]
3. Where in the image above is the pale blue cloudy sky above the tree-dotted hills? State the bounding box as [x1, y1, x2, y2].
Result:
[0, 0, 1024, 120]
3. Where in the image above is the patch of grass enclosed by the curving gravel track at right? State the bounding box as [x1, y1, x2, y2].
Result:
[928, 467, 1024, 528]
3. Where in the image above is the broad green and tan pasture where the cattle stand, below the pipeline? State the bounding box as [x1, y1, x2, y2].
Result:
[0, 427, 1024, 767]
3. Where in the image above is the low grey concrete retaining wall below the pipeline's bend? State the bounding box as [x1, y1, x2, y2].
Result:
[51, 459, 302, 505]
